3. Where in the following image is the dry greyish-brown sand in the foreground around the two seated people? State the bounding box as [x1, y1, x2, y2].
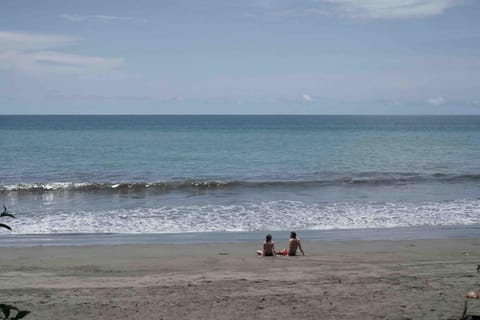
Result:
[0, 238, 480, 320]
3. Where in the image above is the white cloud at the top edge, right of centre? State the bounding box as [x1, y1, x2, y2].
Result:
[322, 0, 463, 19]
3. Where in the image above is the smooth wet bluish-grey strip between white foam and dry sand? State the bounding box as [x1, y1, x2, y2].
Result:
[0, 224, 480, 248]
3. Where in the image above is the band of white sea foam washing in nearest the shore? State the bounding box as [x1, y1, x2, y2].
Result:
[8, 199, 480, 234]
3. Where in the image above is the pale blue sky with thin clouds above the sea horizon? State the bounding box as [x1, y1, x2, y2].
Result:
[0, 0, 480, 114]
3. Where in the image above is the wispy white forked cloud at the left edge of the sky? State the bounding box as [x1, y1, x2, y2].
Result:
[0, 32, 123, 74]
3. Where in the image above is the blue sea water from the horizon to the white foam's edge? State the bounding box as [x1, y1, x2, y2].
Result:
[0, 115, 480, 240]
